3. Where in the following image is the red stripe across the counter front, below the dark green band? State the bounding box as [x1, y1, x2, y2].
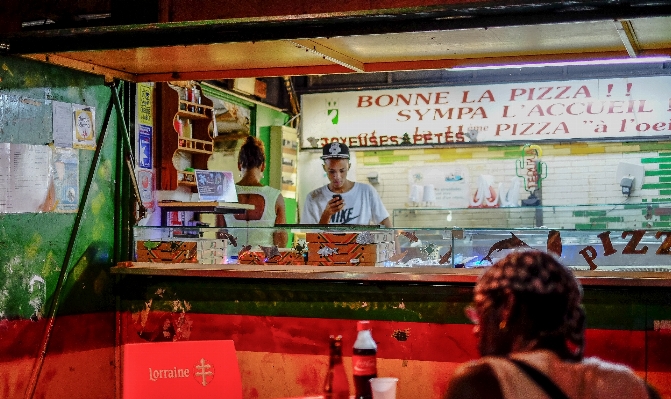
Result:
[124, 313, 645, 371]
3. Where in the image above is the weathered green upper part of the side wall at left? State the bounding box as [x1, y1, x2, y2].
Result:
[0, 58, 117, 317]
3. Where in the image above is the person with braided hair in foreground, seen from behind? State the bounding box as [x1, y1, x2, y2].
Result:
[444, 250, 659, 399]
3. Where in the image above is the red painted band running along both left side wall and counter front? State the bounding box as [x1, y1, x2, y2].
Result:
[0, 312, 671, 399]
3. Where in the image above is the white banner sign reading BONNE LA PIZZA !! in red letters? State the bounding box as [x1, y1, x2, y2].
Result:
[301, 76, 671, 148]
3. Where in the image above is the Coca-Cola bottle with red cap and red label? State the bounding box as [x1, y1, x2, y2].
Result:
[352, 320, 377, 399]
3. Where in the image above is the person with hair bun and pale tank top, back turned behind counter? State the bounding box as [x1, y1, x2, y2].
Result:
[217, 136, 288, 248]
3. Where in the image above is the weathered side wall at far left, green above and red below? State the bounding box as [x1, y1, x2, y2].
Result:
[0, 57, 125, 398]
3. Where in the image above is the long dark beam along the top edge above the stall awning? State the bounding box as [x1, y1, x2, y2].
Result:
[0, 0, 671, 54]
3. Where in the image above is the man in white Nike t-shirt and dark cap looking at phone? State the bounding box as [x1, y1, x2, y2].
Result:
[301, 143, 391, 227]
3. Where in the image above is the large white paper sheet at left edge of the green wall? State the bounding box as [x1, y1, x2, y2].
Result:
[0, 143, 56, 213]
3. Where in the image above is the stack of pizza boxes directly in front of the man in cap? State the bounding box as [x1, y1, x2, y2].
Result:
[305, 231, 395, 266]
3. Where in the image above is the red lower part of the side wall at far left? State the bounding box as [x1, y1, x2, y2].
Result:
[0, 312, 116, 399]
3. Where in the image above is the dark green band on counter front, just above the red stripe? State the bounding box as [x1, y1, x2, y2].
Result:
[120, 276, 671, 331]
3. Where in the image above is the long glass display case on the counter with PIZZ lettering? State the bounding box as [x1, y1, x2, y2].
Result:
[134, 220, 671, 272]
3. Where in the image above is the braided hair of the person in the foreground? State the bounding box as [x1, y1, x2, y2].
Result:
[475, 250, 585, 360]
